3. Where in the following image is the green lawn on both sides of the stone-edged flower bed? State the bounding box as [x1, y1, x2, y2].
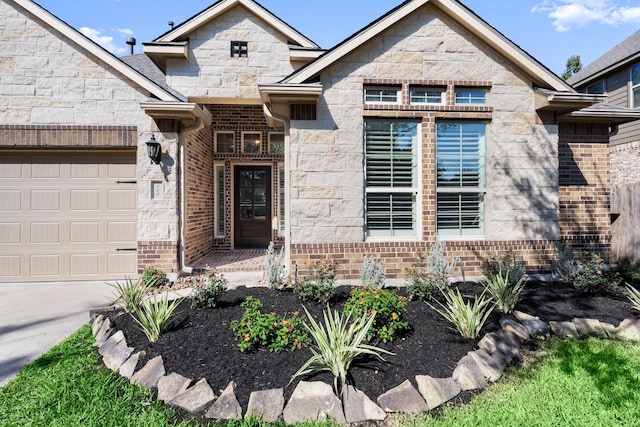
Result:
[0, 326, 640, 427]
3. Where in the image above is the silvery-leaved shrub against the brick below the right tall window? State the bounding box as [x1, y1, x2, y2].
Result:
[407, 240, 454, 301]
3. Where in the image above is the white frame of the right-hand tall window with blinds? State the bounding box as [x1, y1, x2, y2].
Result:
[435, 120, 489, 239]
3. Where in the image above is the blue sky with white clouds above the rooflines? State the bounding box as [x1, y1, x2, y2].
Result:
[35, 0, 640, 74]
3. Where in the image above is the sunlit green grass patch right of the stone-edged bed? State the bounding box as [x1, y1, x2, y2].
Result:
[393, 339, 640, 427]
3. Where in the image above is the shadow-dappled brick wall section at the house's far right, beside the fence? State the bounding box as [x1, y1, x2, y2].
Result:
[559, 123, 611, 259]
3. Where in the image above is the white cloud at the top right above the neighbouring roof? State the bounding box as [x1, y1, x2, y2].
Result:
[531, 0, 640, 31]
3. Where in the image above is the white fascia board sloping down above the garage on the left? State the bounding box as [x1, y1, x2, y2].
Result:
[6, 0, 178, 101]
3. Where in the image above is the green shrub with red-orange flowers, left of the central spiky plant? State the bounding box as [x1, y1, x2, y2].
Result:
[231, 297, 311, 353]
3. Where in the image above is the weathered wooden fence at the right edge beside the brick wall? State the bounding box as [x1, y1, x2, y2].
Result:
[611, 183, 640, 261]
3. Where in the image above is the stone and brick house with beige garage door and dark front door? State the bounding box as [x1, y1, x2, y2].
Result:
[0, 0, 640, 282]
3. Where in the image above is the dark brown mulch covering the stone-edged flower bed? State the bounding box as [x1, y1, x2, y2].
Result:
[111, 282, 635, 410]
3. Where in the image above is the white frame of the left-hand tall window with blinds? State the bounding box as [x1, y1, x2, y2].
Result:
[363, 118, 423, 241]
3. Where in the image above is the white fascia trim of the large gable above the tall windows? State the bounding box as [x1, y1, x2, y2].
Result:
[281, 0, 574, 92]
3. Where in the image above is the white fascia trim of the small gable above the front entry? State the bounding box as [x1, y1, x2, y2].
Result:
[154, 0, 319, 49]
